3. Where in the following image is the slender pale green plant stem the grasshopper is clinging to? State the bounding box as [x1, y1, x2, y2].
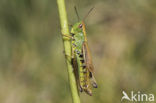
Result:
[57, 0, 80, 103]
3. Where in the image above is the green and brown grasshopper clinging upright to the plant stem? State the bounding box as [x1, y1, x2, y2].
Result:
[64, 8, 97, 96]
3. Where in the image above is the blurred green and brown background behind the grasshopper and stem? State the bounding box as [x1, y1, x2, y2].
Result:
[0, 0, 156, 103]
